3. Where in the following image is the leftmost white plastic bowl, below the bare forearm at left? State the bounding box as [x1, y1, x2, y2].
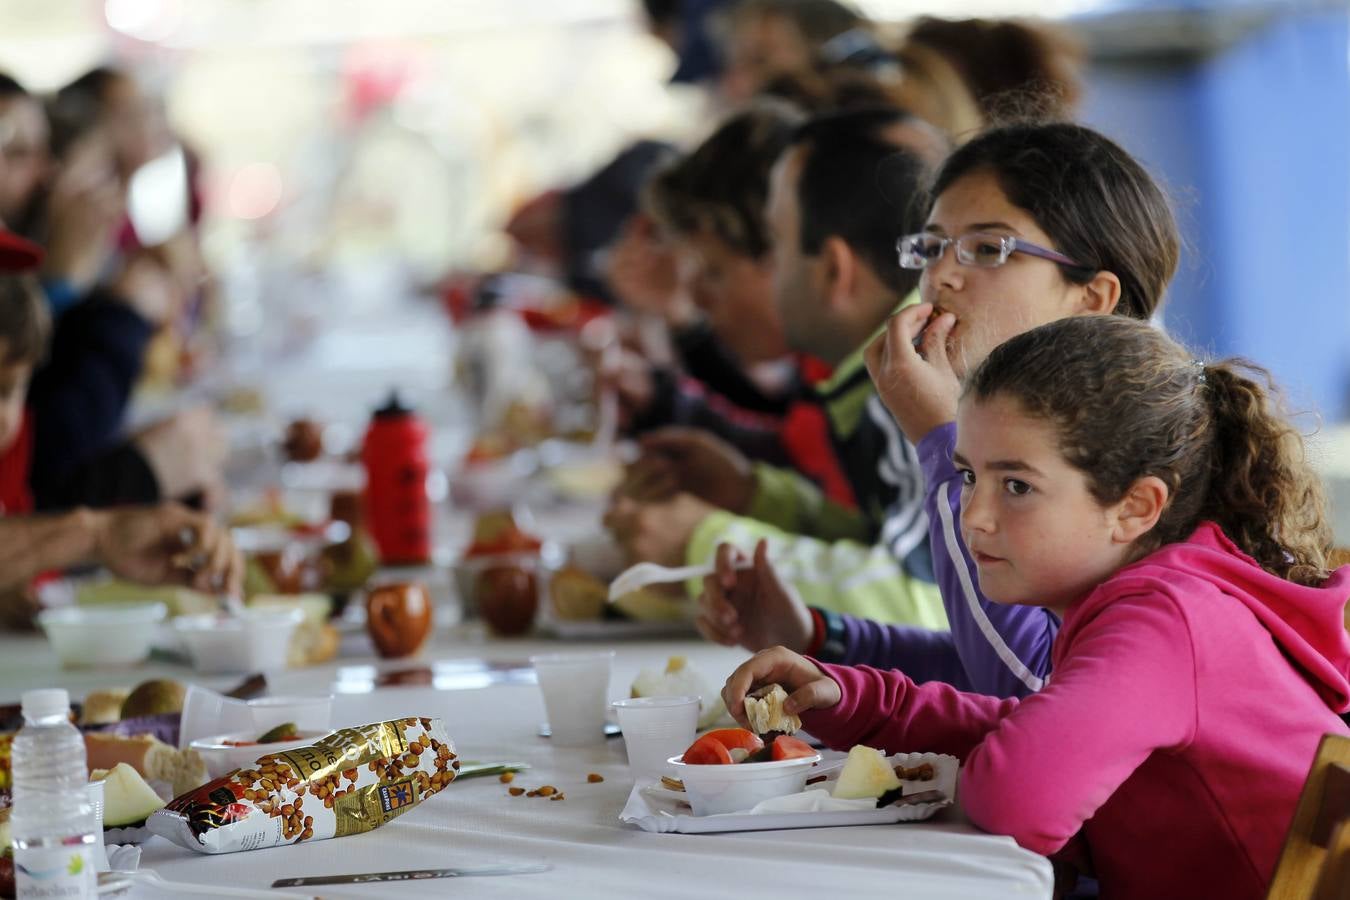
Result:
[38, 603, 167, 668]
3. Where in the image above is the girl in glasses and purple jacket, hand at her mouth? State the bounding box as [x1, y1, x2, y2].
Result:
[699, 123, 1179, 696]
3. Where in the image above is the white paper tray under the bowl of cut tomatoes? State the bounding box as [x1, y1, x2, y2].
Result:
[618, 753, 959, 834]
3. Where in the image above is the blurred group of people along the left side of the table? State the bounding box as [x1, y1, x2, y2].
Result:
[0, 67, 236, 621]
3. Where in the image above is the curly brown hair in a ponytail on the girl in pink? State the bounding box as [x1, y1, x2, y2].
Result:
[965, 316, 1331, 586]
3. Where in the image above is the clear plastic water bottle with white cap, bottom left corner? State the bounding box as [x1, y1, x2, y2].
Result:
[9, 688, 97, 900]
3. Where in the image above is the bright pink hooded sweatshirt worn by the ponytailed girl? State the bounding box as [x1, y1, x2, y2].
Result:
[802, 522, 1350, 900]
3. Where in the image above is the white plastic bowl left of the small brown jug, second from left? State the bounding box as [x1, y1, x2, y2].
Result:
[173, 609, 305, 672]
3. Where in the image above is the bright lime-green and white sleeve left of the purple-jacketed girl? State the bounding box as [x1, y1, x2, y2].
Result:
[686, 511, 948, 631]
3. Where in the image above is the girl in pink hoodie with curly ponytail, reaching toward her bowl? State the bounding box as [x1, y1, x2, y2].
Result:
[724, 316, 1350, 900]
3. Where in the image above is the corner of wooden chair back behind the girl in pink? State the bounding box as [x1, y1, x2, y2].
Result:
[1266, 734, 1350, 900]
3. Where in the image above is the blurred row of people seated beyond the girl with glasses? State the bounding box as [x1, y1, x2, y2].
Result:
[486, 0, 1083, 627]
